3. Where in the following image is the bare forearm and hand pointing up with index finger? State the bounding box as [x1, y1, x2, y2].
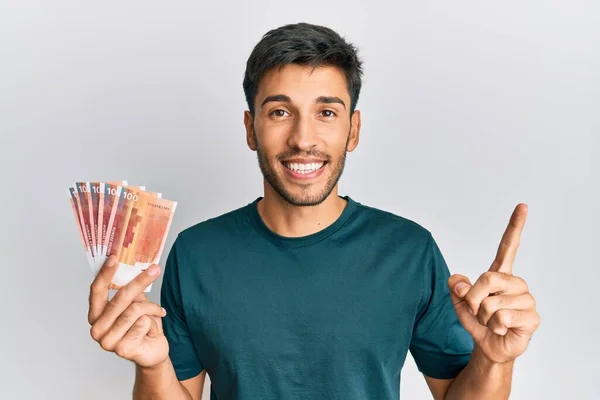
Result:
[436, 204, 540, 400]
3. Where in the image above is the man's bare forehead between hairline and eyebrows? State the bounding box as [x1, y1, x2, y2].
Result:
[256, 64, 350, 104]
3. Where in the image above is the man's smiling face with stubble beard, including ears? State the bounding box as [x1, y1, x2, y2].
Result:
[244, 64, 360, 206]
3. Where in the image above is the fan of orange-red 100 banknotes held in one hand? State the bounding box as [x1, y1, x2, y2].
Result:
[69, 181, 177, 292]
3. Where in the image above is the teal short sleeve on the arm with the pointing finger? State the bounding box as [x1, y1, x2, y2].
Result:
[410, 235, 474, 379]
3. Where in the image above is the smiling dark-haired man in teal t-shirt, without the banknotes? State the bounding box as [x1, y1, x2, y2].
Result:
[89, 24, 539, 400]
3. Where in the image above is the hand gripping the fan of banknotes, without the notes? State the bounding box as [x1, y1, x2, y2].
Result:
[88, 256, 169, 368]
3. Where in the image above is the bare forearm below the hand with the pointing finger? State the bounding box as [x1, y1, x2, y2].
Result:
[445, 346, 514, 400]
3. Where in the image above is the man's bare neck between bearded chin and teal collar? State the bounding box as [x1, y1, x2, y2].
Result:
[257, 184, 347, 237]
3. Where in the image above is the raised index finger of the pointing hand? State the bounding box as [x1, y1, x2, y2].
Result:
[490, 203, 528, 274]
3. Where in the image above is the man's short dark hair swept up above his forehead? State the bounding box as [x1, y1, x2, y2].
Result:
[243, 22, 363, 116]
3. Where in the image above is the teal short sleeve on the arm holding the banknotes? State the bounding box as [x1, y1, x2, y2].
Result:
[160, 240, 203, 381]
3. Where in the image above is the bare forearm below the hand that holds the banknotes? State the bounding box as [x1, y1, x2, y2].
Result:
[133, 358, 206, 400]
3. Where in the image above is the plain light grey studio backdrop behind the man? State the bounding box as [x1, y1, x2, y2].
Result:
[0, 0, 600, 400]
